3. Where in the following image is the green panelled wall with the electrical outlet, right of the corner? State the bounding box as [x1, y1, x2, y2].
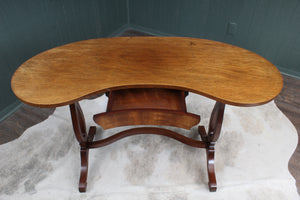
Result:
[129, 0, 300, 78]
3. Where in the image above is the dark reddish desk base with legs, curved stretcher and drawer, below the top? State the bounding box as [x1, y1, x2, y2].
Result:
[70, 89, 225, 192]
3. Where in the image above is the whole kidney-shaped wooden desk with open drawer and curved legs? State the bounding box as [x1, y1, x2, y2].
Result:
[11, 37, 283, 192]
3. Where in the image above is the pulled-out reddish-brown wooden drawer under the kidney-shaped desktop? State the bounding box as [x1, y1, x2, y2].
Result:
[94, 88, 200, 129]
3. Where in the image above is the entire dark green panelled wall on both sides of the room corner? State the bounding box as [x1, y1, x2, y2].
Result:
[0, 0, 300, 121]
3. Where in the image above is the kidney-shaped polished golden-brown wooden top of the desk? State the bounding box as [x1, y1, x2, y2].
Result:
[11, 37, 283, 107]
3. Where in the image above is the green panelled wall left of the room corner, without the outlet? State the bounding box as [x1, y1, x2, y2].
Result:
[0, 0, 128, 118]
